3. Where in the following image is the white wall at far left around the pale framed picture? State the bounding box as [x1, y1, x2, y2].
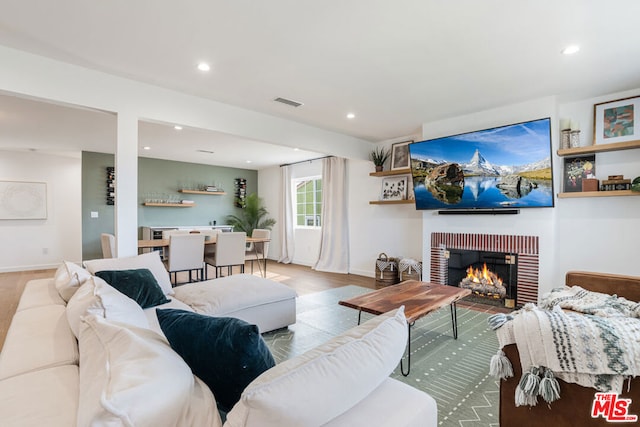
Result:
[0, 151, 82, 271]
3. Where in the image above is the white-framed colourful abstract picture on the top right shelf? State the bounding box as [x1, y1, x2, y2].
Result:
[593, 96, 640, 145]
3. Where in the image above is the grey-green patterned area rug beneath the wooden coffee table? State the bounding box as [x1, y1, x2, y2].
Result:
[264, 286, 499, 427]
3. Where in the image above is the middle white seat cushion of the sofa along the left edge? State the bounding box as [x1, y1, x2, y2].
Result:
[0, 305, 78, 379]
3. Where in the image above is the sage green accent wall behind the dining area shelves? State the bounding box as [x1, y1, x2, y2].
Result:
[82, 151, 258, 259]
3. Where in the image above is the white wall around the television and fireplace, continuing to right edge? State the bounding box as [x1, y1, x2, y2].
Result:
[422, 90, 640, 293]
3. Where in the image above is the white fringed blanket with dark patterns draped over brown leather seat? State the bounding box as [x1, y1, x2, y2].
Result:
[489, 304, 640, 406]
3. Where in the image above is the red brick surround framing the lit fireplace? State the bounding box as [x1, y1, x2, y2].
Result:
[429, 233, 540, 306]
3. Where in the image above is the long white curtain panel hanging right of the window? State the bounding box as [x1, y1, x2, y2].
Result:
[313, 157, 349, 273]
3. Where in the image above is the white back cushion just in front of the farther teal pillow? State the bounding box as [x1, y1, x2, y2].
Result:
[67, 277, 149, 337]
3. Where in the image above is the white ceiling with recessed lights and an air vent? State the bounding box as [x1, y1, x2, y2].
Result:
[0, 0, 640, 168]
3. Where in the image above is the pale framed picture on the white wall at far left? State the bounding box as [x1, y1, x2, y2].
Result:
[0, 181, 47, 219]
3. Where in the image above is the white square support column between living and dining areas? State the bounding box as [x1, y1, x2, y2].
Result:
[115, 111, 138, 257]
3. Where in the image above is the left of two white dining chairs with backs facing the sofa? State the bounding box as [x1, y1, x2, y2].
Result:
[165, 234, 205, 285]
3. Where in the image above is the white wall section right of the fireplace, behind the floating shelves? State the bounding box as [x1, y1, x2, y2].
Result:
[555, 88, 640, 278]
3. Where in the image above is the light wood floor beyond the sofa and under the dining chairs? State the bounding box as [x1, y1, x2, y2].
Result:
[0, 262, 375, 349]
